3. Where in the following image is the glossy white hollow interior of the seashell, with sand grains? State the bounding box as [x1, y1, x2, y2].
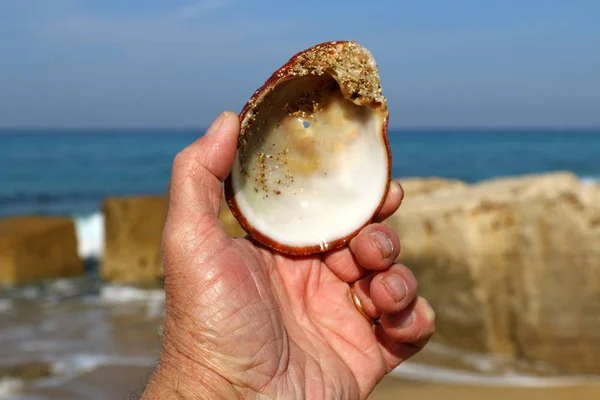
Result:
[231, 75, 388, 250]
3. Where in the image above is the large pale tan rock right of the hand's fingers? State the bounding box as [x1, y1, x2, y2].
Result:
[387, 173, 600, 373]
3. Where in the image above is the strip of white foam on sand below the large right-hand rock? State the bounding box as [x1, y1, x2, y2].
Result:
[391, 362, 600, 387]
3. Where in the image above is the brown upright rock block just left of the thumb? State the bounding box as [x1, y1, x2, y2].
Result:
[101, 196, 168, 285]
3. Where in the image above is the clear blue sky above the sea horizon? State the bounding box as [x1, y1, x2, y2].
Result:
[0, 0, 600, 127]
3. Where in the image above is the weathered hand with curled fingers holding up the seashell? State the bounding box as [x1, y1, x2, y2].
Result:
[143, 113, 434, 399]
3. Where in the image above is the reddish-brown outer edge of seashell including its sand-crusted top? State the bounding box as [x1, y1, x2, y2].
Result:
[224, 41, 392, 256]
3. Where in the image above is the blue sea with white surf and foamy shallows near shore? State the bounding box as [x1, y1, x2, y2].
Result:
[0, 128, 600, 400]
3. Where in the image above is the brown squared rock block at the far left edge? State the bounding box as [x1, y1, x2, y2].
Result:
[0, 216, 83, 284]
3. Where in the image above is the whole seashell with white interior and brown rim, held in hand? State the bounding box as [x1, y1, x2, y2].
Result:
[225, 41, 391, 256]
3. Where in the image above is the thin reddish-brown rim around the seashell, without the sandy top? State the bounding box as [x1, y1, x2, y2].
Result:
[224, 41, 392, 256]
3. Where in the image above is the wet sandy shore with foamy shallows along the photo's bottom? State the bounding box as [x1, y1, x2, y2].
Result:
[0, 281, 600, 400]
